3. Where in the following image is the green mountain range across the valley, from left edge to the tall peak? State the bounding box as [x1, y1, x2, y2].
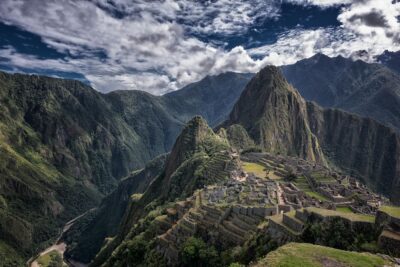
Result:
[0, 72, 248, 266]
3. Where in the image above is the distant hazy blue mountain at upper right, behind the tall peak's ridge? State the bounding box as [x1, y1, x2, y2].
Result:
[282, 54, 400, 131]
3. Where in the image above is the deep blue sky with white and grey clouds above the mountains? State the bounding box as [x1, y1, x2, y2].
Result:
[0, 0, 400, 95]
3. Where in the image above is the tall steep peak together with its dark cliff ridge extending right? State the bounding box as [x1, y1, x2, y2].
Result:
[222, 66, 400, 203]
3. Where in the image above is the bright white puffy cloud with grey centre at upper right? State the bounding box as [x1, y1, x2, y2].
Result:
[248, 0, 400, 65]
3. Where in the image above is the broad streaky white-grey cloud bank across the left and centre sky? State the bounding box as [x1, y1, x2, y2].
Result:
[0, 0, 276, 93]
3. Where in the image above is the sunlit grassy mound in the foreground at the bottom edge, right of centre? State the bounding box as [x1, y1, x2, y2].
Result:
[256, 243, 393, 267]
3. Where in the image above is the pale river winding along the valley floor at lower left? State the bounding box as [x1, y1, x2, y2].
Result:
[28, 208, 94, 267]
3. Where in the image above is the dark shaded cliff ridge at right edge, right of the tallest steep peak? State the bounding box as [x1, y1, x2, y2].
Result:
[308, 103, 400, 203]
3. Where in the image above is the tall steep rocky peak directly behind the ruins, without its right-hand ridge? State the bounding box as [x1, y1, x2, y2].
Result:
[222, 66, 325, 163]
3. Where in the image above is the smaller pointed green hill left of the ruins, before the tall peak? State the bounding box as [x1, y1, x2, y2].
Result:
[74, 117, 237, 266]
